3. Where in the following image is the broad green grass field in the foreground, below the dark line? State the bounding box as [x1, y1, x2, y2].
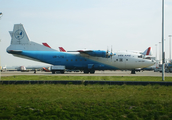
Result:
[0, 84, 172, 120]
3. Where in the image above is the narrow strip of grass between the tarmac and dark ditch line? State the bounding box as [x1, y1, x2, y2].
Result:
[1, 75, 172, 81]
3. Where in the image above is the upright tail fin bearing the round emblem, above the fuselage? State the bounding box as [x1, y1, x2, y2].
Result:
[9, 24, 29, 44]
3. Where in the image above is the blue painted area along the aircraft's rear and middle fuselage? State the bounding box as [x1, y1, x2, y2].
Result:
[20, 51, 118, 70]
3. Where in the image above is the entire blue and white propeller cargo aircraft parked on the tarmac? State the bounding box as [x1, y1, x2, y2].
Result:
[7, 24, 155, 74]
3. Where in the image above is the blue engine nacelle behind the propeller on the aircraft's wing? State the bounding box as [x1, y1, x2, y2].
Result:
[87, 50, 110, 58]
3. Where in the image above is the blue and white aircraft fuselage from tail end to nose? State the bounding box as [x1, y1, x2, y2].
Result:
[9, 51, 154, 70]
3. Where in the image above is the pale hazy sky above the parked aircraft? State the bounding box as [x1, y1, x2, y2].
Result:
[0, 0, 172, 66]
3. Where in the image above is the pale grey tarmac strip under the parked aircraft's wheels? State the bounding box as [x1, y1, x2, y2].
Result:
[0, 71, 172, 77]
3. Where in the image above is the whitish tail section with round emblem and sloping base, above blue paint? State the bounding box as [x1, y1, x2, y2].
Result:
[7, 24, 57, 51]
